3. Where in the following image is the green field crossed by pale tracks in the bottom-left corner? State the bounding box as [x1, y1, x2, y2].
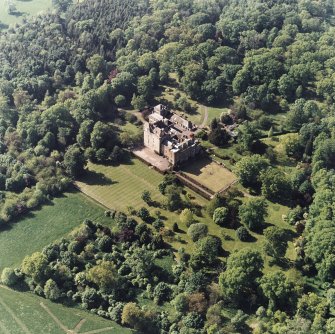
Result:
[0, 287, 132, 334]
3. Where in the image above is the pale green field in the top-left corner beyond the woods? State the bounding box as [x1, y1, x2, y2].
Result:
[0, 0, 52, 28]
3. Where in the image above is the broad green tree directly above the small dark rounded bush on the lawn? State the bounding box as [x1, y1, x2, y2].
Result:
[239, 199, 267, 231]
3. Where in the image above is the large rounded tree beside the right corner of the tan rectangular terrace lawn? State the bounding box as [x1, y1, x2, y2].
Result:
[234, 154, 270, 187]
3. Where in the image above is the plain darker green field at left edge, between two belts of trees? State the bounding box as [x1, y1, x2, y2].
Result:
[0, 191, 110, 270]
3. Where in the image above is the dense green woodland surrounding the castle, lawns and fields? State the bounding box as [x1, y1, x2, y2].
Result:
[0, 0, 335, 334]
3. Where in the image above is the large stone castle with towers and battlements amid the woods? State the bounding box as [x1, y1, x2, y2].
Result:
[144, 104, 200, 166]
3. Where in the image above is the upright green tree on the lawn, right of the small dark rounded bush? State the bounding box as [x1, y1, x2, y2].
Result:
[264, 226, 288, 259]
